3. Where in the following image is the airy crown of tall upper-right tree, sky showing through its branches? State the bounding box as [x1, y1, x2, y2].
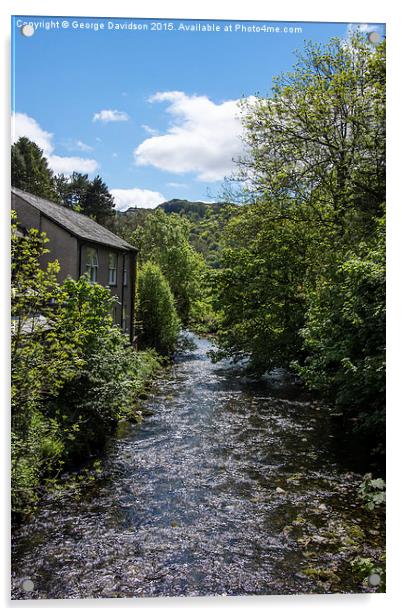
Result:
[239, 36, 385, 232]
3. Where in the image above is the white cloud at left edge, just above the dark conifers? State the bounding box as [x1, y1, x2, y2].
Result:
[11, 113, 99, 174]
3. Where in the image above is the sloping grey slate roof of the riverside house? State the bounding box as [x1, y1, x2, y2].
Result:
[11, 187, 137, 251]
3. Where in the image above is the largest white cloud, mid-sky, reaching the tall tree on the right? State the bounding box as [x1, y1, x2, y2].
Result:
[134, 92, 247, 182]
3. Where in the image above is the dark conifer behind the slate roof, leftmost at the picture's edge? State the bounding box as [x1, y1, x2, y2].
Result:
[11, 137, 57, 200]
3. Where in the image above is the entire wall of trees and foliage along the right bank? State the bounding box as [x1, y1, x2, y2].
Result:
[215, 37, 385, 436]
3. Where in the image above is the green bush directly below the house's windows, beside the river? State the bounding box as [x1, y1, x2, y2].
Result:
[47, 276, 151, 463]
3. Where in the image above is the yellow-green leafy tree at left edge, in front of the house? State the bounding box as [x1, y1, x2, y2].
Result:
[11, 214, 80, 424]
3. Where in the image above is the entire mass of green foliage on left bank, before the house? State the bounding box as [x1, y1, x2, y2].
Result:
[11, 217, 158, 513]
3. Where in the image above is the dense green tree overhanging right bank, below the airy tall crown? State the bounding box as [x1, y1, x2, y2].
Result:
[214, 203, 311, 372]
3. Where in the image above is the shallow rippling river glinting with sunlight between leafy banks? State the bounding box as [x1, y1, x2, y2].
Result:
[12, 339, 383, 599]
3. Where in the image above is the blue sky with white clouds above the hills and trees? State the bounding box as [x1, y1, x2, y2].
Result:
[12, 16, 383, 210]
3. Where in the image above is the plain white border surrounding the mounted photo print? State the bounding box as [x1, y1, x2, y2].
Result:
[0, 0, 402, 616]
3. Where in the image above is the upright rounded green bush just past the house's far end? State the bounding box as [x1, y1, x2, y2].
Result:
[138, 262, 180, 355]
